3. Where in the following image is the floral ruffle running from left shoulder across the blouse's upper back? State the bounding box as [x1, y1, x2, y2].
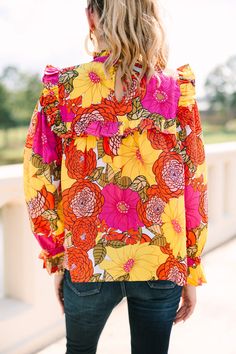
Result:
[41, 65, 176, 138]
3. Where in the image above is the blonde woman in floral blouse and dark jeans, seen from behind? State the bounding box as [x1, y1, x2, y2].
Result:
[24, 0, 208, 354]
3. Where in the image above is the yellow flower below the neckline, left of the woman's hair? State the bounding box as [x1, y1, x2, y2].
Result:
[70, 62, 114, 108]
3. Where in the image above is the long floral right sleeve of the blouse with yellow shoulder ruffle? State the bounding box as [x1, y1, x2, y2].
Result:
[177, 64, 208, 286]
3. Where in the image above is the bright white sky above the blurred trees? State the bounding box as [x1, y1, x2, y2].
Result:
[0, 0, 236, 97]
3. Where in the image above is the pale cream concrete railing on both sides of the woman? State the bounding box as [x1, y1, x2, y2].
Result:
[0, 142, 236, 354]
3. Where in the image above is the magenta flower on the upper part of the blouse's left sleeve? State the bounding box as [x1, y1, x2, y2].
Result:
[33, 112, 58, 163]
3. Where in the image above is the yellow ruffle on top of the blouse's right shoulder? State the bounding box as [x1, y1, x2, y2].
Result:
[177, 64, 196, 107]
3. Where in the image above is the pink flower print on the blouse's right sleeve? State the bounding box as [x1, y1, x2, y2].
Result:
[184, 185, 201, 230]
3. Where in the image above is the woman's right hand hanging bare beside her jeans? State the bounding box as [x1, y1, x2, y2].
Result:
[174, 284, 197, 324]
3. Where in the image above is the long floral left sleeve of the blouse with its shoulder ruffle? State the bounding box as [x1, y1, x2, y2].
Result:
[23, 65, 64, 274]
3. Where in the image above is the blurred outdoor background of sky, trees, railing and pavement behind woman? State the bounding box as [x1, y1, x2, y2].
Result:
[0, 0, 236, 354]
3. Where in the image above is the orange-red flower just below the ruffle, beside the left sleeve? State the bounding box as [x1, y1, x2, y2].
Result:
[65, 139, 97, 179]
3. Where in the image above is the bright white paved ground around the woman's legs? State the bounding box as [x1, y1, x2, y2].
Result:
[38, 238, 236, 354]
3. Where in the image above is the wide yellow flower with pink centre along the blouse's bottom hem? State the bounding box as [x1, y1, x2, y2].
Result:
[99, 242, 168, 281]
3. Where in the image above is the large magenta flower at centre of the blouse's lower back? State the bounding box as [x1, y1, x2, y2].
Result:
[99, 183, 144, 231]
